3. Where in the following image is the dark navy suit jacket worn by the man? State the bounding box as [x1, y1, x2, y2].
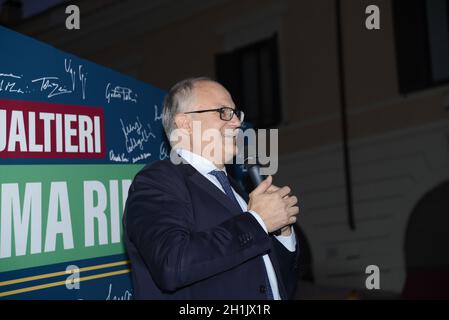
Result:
[123, 159, 299, 300]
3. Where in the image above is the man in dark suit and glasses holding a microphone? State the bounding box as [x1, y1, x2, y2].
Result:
[123, 78, 299, 300]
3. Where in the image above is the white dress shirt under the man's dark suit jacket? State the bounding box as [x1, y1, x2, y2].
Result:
[176, 149, 296, 300]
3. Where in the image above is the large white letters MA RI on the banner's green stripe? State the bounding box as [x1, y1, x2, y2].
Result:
[0, 179, 132, 259]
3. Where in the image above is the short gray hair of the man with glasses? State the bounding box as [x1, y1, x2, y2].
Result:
[162, 77, 214, 140]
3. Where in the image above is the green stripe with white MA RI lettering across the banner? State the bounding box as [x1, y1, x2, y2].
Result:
[0, 164, 143, 272]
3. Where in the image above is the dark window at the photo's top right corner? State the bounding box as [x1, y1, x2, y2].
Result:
[393, 0, 449, 93]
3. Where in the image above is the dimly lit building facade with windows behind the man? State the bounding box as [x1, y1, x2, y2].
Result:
[7, 0, 449, 297]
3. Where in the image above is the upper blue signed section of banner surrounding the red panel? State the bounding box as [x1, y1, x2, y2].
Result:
[0, 24, 166, 164]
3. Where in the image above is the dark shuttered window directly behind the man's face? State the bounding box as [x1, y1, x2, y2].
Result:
[215, 34, 281, 128]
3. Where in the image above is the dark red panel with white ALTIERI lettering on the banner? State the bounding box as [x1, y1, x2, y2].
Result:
[0, 101, 105, 157]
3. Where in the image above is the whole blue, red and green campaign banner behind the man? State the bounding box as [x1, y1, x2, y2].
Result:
[0, 27, 169, 299]
